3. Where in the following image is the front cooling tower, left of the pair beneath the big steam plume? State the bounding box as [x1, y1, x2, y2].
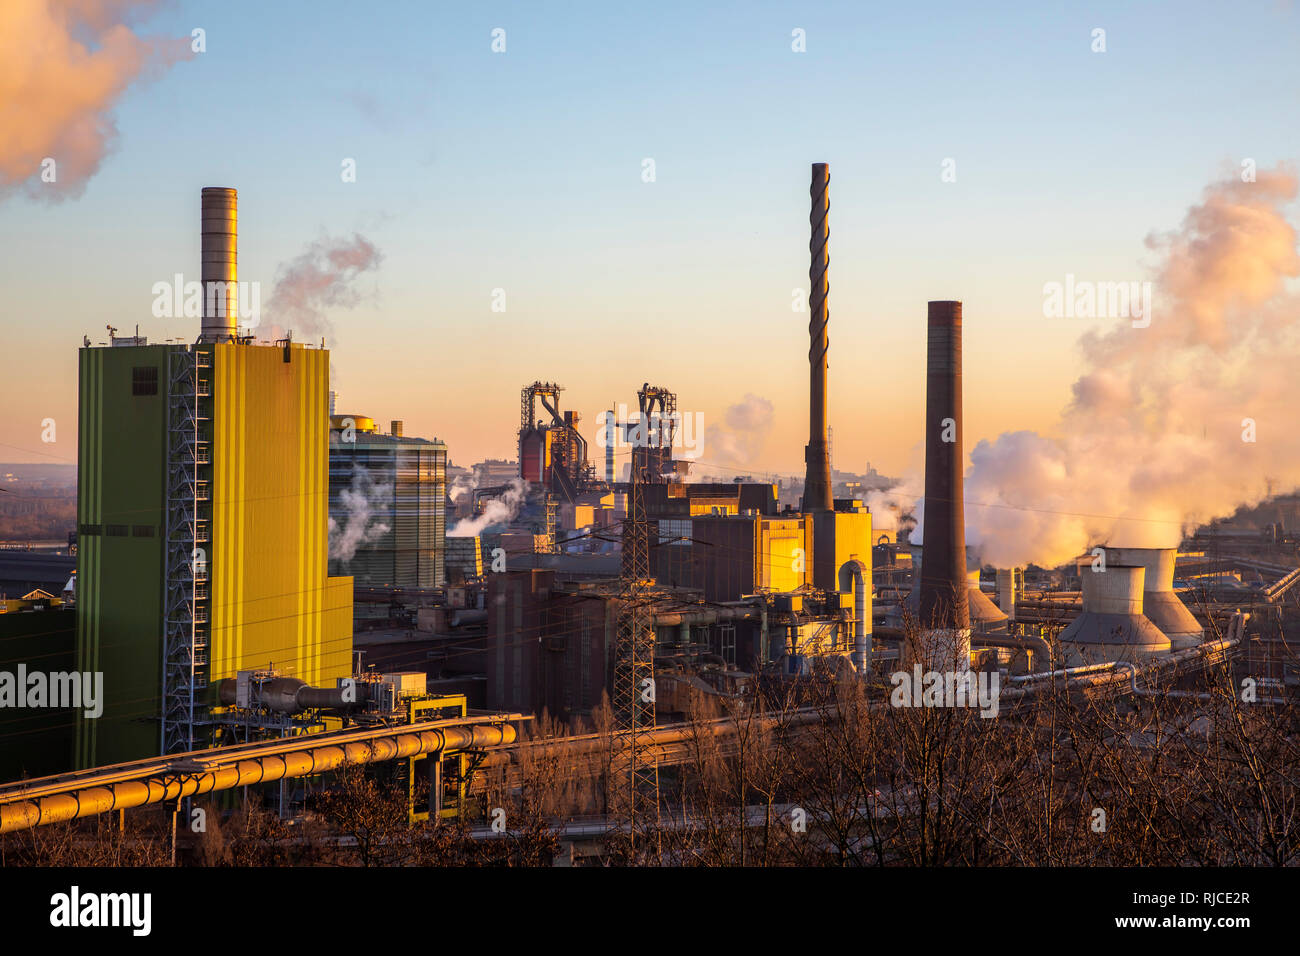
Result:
[1061, 563, 1171, 667]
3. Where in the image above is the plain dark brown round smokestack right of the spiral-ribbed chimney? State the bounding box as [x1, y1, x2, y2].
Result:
[917, 302, 970, 666]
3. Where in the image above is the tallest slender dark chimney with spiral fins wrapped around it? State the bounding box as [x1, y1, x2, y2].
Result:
[803, 163, 832, 512]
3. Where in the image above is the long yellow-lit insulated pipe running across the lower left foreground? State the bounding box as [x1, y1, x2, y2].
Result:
[0, 723, 515, 834]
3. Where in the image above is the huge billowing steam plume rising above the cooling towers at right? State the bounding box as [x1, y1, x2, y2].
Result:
[961, 168, 1300, 567]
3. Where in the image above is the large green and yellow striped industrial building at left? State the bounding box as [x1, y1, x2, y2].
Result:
[74, 339, 352, 767]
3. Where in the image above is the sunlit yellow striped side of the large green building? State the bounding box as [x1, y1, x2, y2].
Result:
[208, 343, 352, 687]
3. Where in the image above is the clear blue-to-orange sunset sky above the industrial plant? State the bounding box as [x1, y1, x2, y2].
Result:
[0, 0, 1300, 475]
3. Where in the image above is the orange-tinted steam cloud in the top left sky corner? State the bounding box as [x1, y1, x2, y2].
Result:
[0, 0, 194, 200]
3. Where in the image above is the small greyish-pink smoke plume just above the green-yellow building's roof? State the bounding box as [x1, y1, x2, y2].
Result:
[256, 233, 384, 339]
